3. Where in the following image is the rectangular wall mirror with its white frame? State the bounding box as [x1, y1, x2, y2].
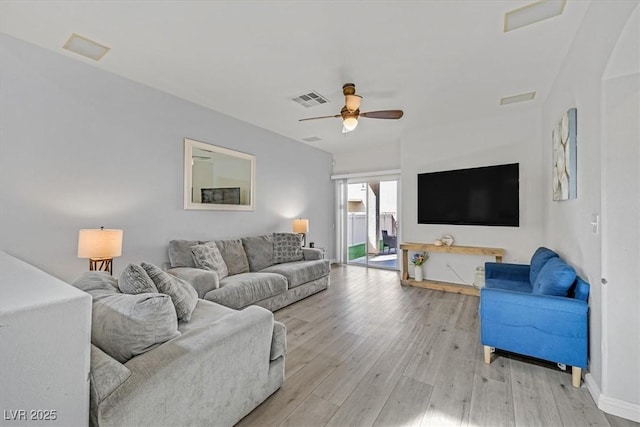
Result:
[184, 138, 256, 211]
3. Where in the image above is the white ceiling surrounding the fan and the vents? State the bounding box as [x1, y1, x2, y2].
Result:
[0, 0, 589, 153]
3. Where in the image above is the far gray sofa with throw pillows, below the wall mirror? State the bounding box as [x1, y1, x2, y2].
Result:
[168, 233, 330, 311]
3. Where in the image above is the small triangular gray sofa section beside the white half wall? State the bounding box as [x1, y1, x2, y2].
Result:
[89, 344, 131, 405]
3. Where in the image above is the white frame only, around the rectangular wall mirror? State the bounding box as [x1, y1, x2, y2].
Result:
[184, 138, 256, 211]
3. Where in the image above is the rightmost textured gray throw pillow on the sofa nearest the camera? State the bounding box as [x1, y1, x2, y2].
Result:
[141, 262, 198, 322]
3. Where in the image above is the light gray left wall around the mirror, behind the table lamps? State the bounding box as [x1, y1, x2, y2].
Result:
[0, 35, 333, 280]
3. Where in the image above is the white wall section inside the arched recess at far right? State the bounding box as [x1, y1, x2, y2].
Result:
[601, 1, 640, 422]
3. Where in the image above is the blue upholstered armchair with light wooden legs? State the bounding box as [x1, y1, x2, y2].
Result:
[479, 248, 589, 387]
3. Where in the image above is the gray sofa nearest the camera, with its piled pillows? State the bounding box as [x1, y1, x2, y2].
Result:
[73, 272, 286, 427]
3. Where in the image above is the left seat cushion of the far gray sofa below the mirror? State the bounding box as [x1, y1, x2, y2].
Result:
[204, 272, 287, 309]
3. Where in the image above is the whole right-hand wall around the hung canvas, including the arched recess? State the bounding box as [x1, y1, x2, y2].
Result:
[542, 1, 640, 421]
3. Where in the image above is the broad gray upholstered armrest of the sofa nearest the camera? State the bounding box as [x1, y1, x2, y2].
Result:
[98, 306, 274, 426]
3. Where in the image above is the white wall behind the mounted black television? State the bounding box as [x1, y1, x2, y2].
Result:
[400, 108, 544, 284]
